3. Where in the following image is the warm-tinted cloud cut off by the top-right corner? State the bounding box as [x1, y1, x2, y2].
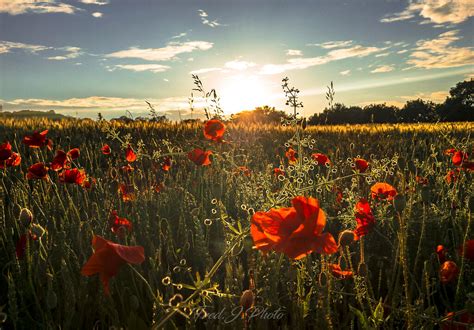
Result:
[380, 0, 474, 24]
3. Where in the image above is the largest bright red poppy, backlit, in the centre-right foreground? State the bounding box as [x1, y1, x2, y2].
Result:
[250, 196, 337, 259]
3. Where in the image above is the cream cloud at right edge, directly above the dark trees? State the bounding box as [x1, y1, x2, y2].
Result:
[407, 30, 474, 69]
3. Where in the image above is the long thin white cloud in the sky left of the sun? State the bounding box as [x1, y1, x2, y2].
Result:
[106, 41, 213, 61]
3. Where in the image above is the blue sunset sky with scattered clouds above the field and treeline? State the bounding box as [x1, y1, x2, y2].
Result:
[0, 0, 474, 119]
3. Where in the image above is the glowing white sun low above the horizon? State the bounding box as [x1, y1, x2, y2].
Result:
[217, 74, 276, 115]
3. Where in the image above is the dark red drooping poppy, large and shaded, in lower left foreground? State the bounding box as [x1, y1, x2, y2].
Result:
[81, 236, 145, 294]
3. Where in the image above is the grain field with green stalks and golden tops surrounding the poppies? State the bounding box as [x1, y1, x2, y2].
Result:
[0, 119, 474, 329]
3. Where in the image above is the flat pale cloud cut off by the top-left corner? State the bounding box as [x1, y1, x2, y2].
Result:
[0, 0, 81, 15]
